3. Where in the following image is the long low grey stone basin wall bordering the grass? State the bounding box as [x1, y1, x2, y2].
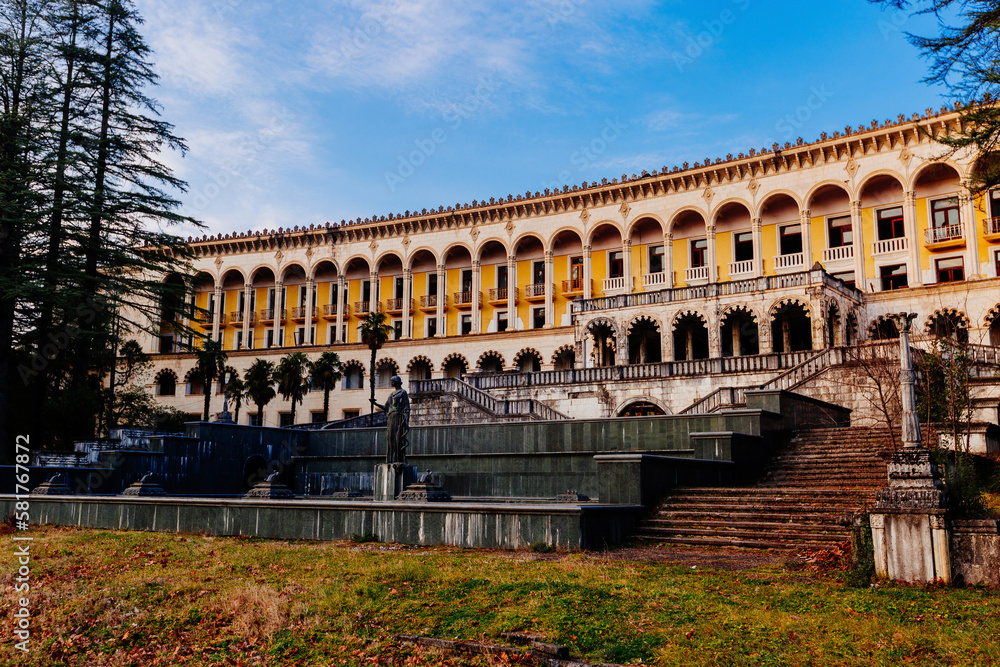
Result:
[0, 494, 644, 549]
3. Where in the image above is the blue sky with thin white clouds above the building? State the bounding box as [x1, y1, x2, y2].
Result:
[137, 0, 947, 240]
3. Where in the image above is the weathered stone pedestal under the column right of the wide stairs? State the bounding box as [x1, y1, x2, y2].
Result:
[870, 447, 951, 584]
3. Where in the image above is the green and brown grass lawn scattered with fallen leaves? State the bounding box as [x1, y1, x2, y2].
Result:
[0, 527, 1000, 667]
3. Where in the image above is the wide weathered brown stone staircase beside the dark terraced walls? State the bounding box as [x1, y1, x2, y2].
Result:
[636, 427, 904, 552]
